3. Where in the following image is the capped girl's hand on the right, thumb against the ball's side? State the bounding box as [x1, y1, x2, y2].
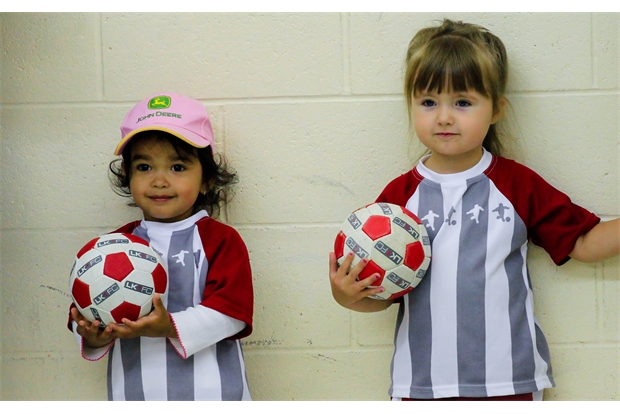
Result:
[112, 294, 177, 339]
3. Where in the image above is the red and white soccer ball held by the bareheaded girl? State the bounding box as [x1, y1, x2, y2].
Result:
[334, 203, 431, 299]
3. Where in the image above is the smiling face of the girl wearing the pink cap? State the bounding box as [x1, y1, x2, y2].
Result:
[125, 137, 206, 223]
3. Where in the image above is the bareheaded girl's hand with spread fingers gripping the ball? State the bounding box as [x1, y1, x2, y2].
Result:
[329, 252, 392, 312]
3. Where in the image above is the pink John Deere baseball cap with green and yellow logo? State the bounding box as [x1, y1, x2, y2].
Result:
[114, 93, 214, 155]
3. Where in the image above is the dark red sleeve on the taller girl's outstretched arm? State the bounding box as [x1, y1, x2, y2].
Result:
[487, 157, 600, 265]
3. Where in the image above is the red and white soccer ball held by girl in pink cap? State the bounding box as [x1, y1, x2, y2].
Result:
[69, 233, 168, 326]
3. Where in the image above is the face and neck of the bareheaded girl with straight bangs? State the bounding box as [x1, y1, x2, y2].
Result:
[412, 89, 500, 174]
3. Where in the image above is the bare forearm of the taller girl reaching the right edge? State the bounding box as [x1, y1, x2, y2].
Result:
[570, 219, 620, 263]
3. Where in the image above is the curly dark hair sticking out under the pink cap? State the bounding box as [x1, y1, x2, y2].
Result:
[109, 131, 238, 217]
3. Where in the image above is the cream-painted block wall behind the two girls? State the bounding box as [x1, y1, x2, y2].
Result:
[0, 13, 620, 400]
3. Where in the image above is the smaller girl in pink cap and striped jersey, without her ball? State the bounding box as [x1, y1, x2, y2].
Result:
[69, 93, 254, 400]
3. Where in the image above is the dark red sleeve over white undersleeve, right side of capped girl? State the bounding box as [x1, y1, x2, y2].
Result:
[197, 217, 254, 339]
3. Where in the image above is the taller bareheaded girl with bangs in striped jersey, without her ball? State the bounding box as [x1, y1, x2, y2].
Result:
[330, 20, 620, 400]
